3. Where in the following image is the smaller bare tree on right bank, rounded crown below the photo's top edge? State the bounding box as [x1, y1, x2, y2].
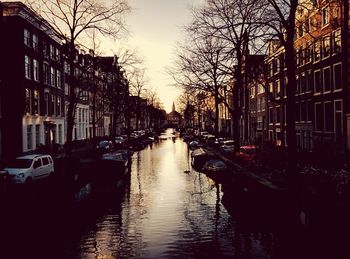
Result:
[169, 35, 232, 135]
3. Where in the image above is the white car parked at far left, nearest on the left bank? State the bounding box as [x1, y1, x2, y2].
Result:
[4, 154, 54, 184]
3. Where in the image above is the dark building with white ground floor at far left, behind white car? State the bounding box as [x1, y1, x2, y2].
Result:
[0, 2, 65, 159]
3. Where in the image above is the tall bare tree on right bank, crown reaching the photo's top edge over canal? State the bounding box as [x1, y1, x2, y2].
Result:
[171, 0, 262, 151]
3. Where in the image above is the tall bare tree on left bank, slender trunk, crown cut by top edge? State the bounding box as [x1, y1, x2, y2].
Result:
[27, 0, 130, 152]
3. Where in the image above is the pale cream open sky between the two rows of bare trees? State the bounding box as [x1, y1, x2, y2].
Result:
[105, 0, 204, 112]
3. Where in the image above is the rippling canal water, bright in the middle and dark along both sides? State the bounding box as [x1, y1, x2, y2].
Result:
[0, 129, 348, 259]
